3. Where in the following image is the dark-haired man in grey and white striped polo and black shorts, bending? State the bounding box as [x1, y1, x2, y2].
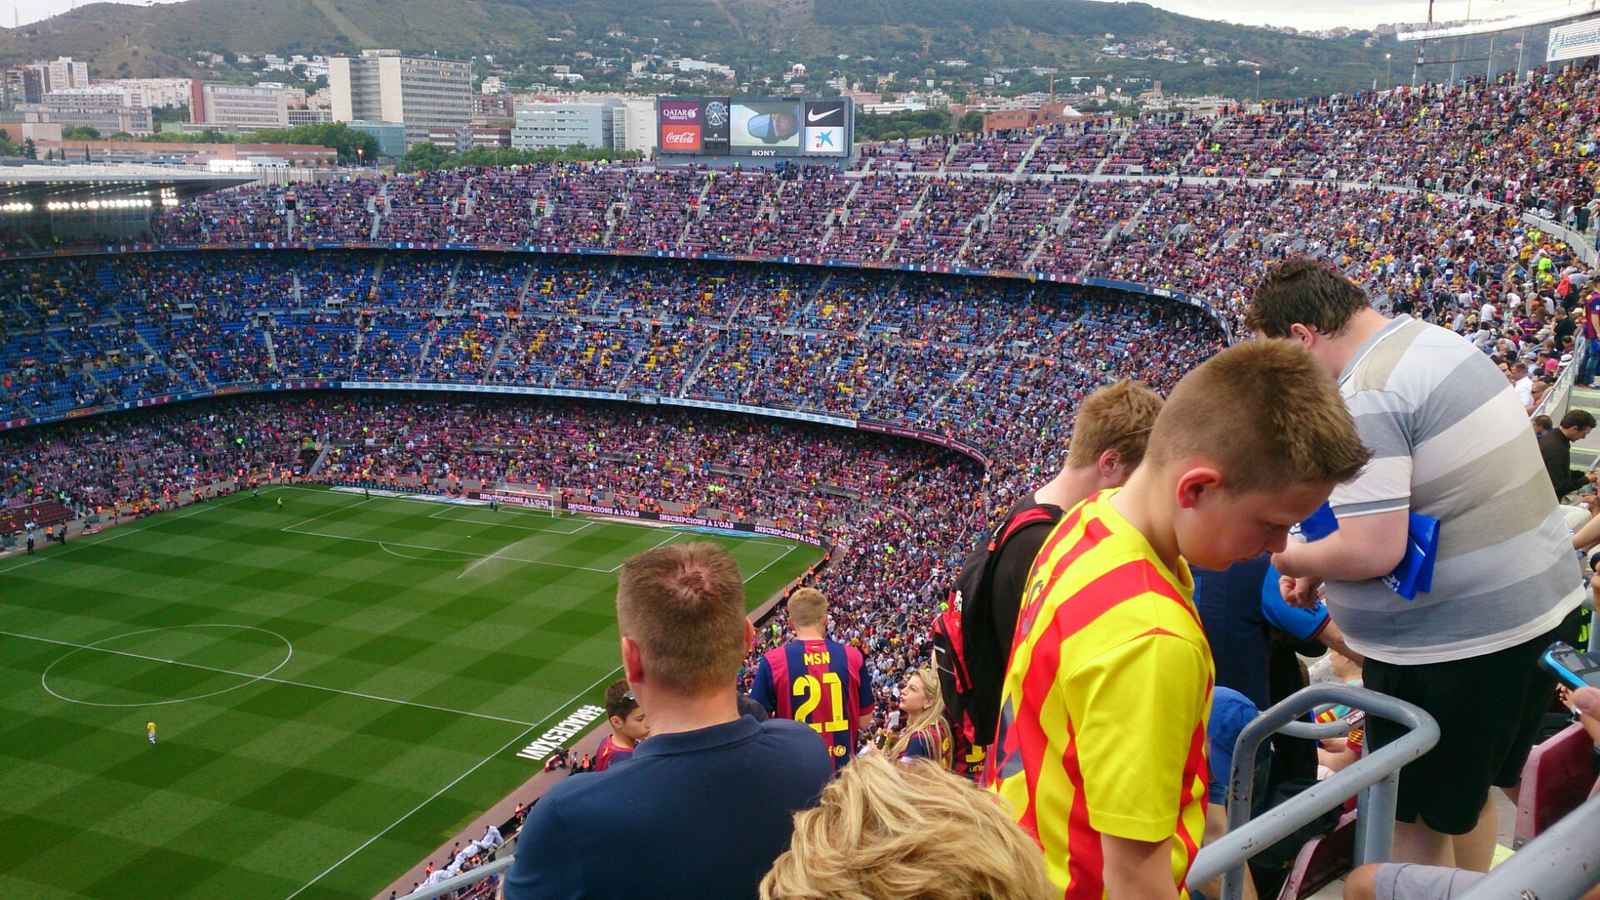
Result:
[1246, 259, 1584, 871]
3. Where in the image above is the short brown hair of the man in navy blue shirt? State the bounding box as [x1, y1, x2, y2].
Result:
[616, 543, 747, 693]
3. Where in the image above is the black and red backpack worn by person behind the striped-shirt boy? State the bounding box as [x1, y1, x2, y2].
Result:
[933, 504, 1061, 746]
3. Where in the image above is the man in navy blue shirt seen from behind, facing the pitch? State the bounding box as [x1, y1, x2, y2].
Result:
[502, 543, 832, 900]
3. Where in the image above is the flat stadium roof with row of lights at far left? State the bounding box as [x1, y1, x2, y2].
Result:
[0, 163, 256, 205]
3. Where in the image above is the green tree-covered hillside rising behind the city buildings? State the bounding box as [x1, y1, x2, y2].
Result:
[0, 0, 1392, 94]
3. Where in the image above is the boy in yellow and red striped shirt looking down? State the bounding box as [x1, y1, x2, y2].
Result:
[989, 341, 1368, 900]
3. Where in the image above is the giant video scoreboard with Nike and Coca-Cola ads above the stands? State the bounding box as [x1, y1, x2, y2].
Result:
[656, 96, 856, 157]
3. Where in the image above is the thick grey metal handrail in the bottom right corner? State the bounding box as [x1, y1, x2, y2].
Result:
[1461, 794, 1600, 900]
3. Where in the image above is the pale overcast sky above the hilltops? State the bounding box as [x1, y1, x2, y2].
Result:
[0, 0, 1586, 29]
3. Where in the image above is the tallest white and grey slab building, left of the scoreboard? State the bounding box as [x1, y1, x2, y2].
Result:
[328, 50, 472, 147]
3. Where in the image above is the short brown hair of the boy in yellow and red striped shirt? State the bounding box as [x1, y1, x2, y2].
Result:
[1149, 340, 1371, 492]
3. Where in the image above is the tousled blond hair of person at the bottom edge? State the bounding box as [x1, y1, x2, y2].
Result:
[762, 753, 1061, 900]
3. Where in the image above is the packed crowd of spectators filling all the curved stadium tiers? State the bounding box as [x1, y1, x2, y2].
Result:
[0, 59, 1600, 896]
